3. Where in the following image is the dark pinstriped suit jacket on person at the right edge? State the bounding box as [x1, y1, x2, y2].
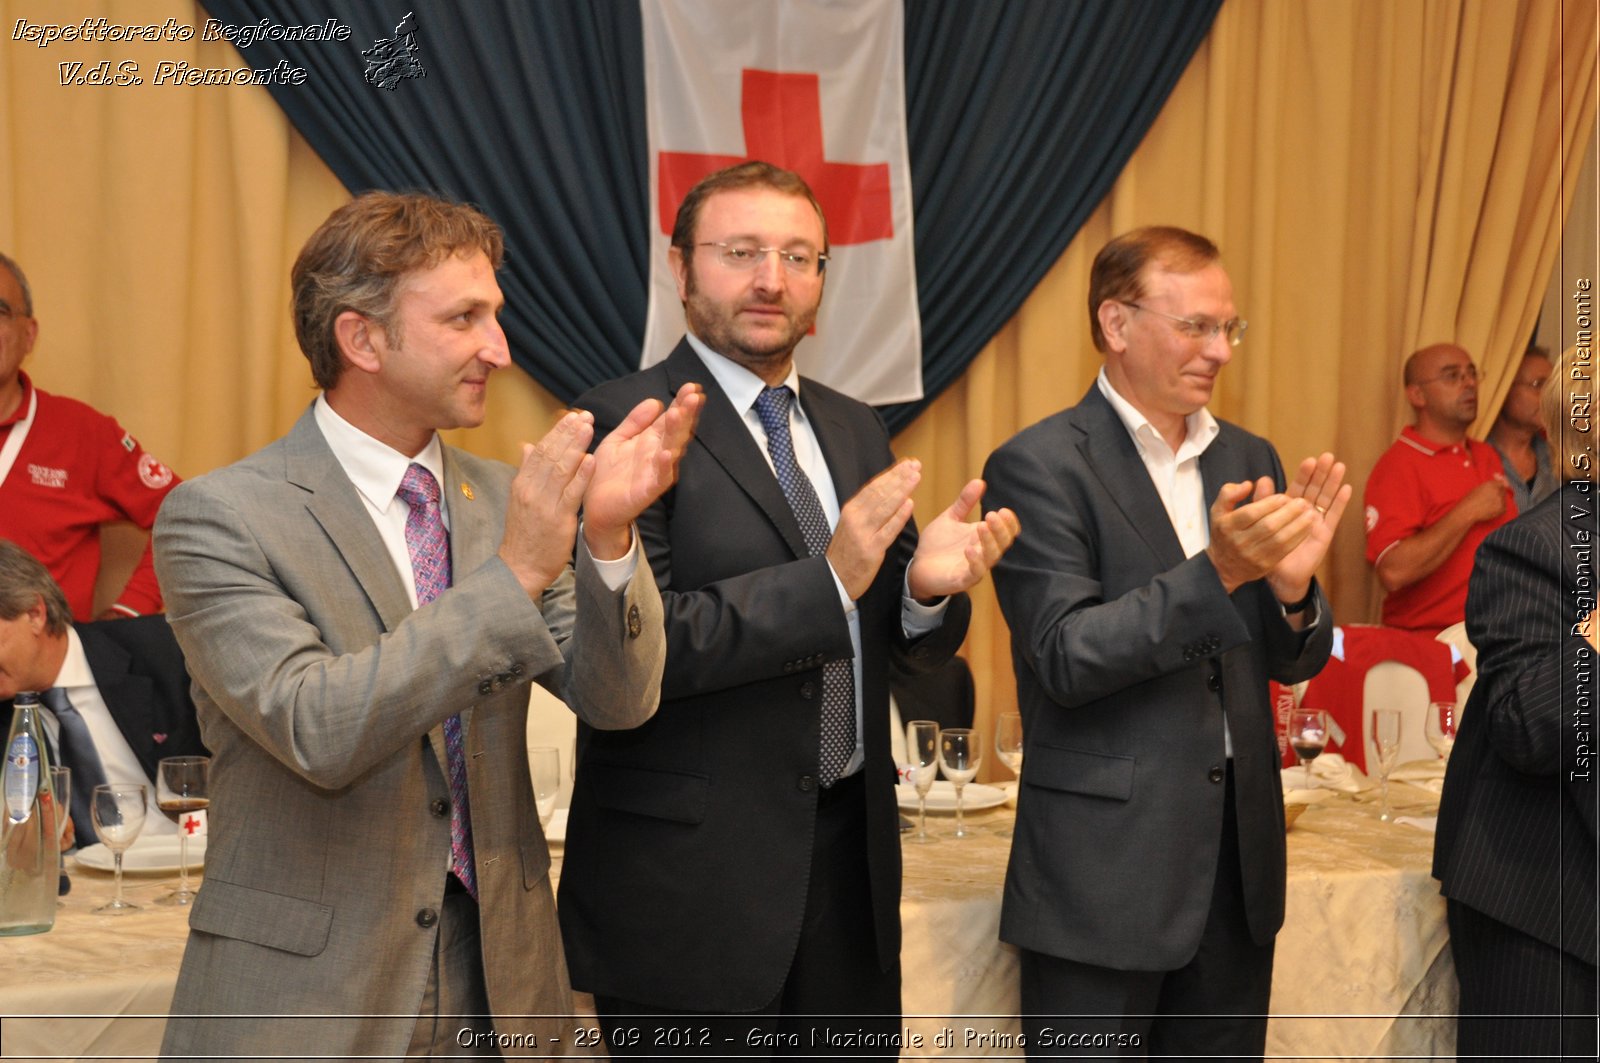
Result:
[1434, 483, 1600, 964]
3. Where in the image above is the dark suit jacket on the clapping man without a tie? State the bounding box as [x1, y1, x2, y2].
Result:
[984, 386, 1333, 970]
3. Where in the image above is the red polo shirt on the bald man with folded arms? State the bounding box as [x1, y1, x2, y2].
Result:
[1366, 426, 1517, 634]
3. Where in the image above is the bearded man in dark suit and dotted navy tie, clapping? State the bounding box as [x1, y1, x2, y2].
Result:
[558, 163, 1016, 1055]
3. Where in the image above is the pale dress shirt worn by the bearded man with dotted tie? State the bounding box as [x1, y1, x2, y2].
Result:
[688, 333, 950, 776]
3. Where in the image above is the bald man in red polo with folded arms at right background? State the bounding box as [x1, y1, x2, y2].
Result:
[1365, 343, 1517, 634]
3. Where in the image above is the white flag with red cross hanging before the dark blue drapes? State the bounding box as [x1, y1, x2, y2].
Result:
[640, 0, 922, 405]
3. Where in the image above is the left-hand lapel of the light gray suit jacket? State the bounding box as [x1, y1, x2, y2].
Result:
[285, 410, 411, 631]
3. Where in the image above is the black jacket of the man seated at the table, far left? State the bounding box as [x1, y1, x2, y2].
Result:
[3, 615, 208, 783]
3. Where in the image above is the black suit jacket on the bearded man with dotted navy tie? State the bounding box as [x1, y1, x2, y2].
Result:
[558, 341, 971, 1012]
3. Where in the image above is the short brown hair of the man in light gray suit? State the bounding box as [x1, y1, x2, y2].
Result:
[290, 192, 506, 391]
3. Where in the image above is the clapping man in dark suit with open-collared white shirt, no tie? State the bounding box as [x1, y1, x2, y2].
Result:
[984, 227, 1350, 1058]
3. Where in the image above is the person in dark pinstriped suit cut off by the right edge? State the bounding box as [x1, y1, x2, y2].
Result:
[1434, 351, 1600, 1060]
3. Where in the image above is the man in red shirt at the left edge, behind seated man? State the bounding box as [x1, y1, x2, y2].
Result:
[0, 255, 178, 621]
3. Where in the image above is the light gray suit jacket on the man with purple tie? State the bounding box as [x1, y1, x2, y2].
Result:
[155, 411, 664, 1057]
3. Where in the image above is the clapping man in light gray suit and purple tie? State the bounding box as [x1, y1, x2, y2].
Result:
[155, 192, 701, 1057]
